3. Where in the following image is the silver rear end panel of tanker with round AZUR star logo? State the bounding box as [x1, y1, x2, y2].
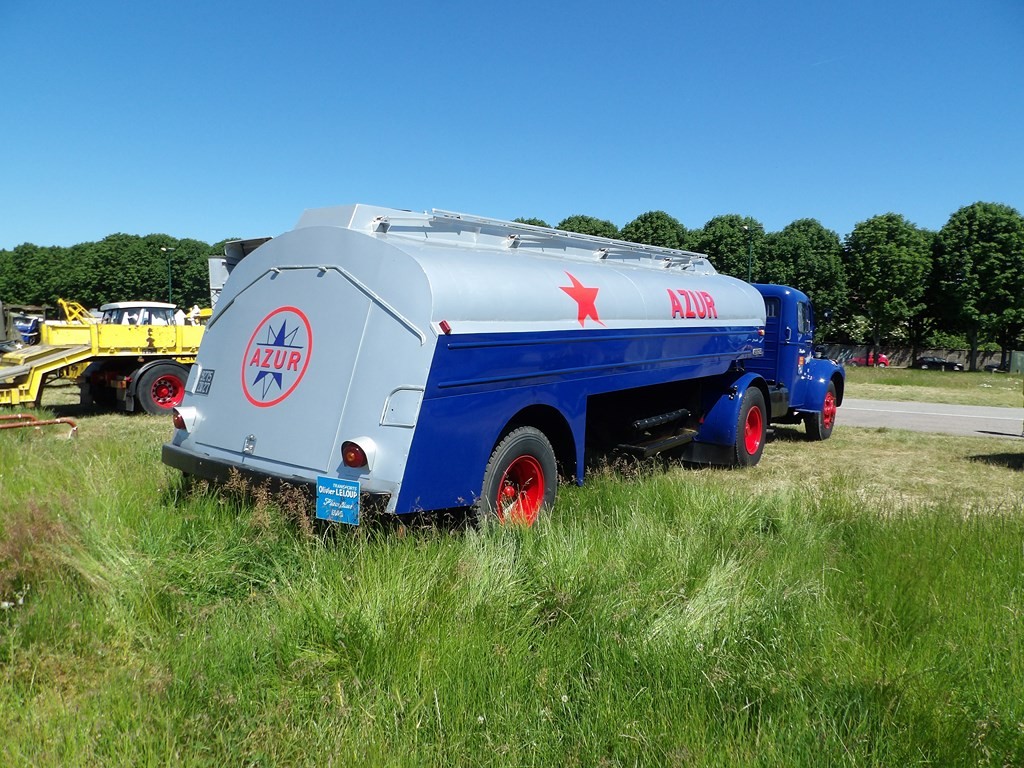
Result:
[175, 222, 435, 489]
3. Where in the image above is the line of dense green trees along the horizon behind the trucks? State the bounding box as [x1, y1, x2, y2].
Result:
[0, 202, 1024, 368]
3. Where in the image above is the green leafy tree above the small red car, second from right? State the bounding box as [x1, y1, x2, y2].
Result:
[844, 213, 932, 350]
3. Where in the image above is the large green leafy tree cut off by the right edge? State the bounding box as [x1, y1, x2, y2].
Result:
[935, 203, 1024, 371]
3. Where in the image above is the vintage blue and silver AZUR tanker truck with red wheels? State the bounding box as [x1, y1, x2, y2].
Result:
[162, 205, 845, 524]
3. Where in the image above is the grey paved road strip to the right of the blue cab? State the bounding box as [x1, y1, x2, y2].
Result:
[838, 397, 1024, 439]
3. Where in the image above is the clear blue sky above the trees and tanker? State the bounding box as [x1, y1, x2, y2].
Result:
[0, 0, 1024, 248]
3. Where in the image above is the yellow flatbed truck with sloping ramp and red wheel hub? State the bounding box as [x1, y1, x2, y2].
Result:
[0, 300, 208, 414]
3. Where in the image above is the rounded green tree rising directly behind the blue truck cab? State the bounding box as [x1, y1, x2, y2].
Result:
[762, 219, 849, 336]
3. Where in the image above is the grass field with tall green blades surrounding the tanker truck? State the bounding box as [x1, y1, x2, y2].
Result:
[0, 382, 1024, 766]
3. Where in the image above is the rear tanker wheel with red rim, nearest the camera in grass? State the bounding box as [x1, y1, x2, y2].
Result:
[473, 427, 558, 525]
